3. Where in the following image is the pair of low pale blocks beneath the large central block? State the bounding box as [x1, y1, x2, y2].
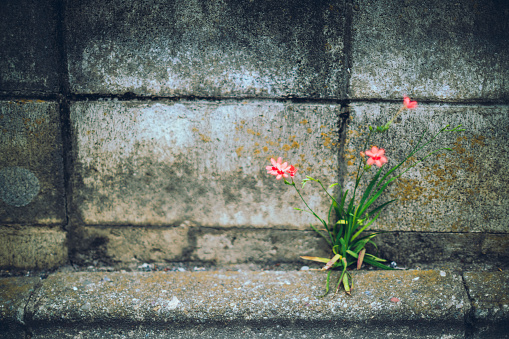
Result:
[72, 226, 329, 268]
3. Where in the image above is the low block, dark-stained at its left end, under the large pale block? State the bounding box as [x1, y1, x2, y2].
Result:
[72, 227, 189, 266]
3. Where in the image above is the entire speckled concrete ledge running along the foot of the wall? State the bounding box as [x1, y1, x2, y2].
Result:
[0, 270, 508, 338]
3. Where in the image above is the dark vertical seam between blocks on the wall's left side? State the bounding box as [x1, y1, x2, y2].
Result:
[56, 0, 72, 239]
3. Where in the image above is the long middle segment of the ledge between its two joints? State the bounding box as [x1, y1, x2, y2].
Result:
[20, 271, 470, 338]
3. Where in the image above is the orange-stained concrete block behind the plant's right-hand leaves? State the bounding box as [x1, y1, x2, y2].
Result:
[343, 103, 509, 233]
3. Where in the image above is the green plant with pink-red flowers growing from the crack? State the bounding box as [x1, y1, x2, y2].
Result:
[266, 96, 464, 297]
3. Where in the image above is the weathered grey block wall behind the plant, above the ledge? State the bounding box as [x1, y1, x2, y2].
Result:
[0, 0, 509, 268]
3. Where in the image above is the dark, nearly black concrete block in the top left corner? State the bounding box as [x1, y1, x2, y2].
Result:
[0, 0, 59, 94]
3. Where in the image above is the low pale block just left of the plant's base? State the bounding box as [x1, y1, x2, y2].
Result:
[191, 229, 330, 265]
